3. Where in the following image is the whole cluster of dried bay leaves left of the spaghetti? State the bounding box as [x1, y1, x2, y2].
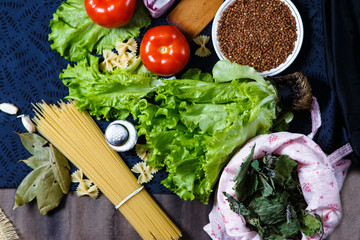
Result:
[14, 133, 71, 214]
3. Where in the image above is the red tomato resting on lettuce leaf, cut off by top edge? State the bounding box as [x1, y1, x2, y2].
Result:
[85, 0, 136, 28]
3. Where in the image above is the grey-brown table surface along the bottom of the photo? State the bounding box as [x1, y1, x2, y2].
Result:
[0, 169, 360, 240]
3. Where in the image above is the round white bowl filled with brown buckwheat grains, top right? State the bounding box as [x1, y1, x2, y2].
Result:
[211, 0, 304, 76]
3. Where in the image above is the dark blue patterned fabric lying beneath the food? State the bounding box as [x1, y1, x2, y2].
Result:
[0, 0, 344, 193]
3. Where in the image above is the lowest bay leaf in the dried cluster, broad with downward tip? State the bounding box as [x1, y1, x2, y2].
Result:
[36, 167, 64, 215]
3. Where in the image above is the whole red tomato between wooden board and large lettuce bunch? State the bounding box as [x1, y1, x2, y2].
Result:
[140, 25, 190, 76]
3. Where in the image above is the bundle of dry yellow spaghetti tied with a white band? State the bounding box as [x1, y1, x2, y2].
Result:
[34, 101, 181, 239]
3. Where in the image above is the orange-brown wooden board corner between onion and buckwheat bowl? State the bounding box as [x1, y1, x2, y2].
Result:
[166, 0, 223, 41]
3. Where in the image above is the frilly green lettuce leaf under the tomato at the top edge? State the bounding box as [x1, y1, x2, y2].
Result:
[49, 0, 151, 62]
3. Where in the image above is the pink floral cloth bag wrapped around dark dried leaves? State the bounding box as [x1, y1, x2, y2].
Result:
[204, 98, 352, 240]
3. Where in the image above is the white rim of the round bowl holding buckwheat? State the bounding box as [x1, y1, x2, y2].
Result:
[211, 0, 304, 76]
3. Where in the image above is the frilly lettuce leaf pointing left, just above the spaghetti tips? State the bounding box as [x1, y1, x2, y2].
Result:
[60, 56, 161, 119]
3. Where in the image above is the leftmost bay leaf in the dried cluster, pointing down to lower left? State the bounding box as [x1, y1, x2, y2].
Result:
[13, 166, 49, 209]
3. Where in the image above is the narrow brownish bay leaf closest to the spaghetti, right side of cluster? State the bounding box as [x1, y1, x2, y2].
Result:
[50, 144, 71, 194]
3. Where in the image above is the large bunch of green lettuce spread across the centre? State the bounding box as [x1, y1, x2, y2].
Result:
[60, 56, 288, 203]
